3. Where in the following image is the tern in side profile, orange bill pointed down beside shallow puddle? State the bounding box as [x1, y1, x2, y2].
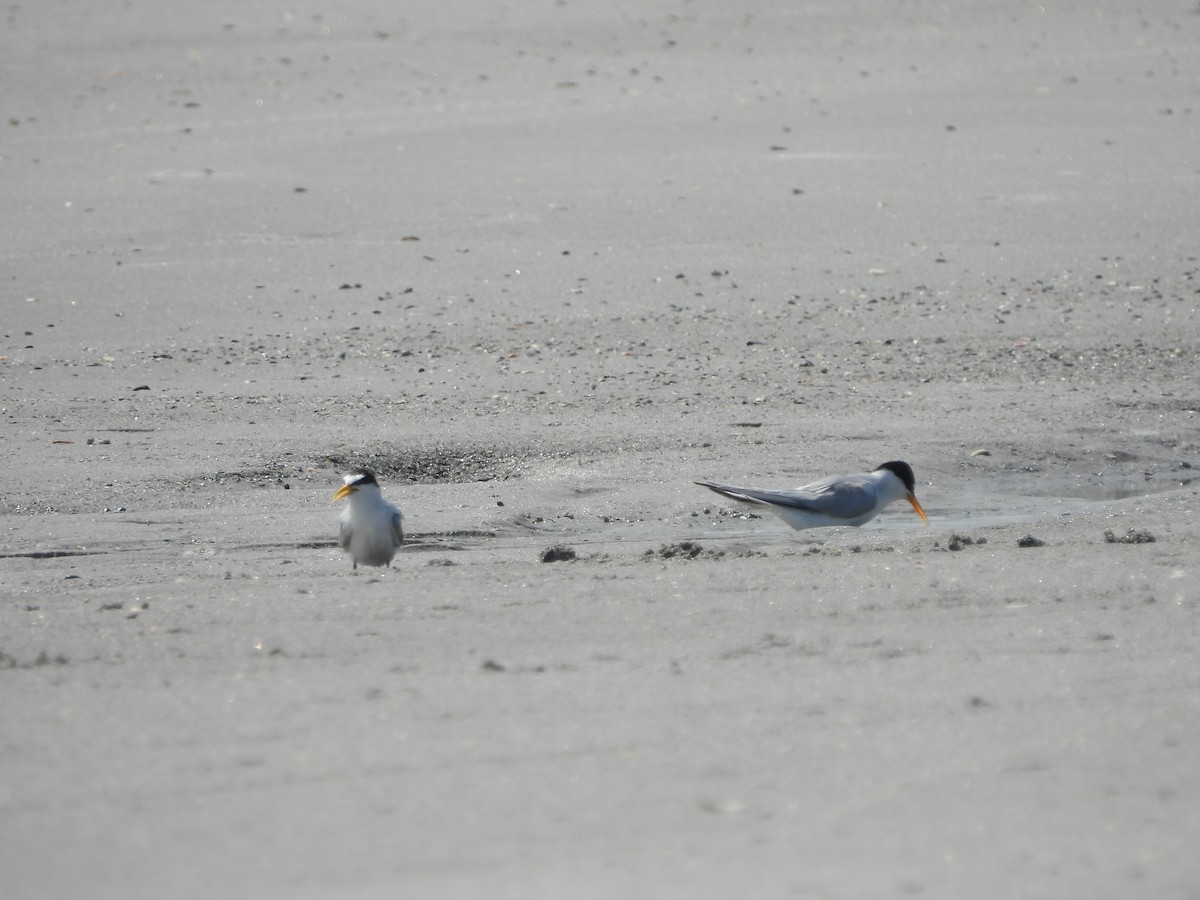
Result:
[696, 461, 929, 530]
